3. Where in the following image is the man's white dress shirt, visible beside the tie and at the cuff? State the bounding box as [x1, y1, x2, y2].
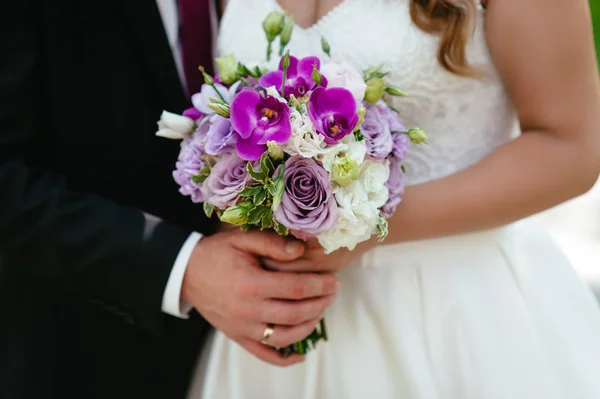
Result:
[156, 0, 202, 319]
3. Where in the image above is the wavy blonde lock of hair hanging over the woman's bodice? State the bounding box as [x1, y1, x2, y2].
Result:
[410, 0, 485, 76]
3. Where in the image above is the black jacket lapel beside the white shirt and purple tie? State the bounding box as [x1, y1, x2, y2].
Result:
[114, 0, 189, 112]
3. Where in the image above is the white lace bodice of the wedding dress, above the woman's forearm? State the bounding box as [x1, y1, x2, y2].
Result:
[217, 0, 517, 184]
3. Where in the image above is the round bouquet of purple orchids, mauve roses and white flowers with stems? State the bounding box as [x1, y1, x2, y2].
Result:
[157, 12, 426, 353]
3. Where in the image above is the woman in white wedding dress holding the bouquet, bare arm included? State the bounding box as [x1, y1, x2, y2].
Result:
[190, 0, 600, 399]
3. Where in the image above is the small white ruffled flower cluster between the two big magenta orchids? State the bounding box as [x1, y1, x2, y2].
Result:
[283, 108, 330, 158]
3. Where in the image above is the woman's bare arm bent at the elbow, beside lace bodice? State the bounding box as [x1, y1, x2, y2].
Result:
[386, 0, 600, 243]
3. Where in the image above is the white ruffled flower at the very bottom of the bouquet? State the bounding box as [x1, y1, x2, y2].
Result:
[317, 208, 377, 254]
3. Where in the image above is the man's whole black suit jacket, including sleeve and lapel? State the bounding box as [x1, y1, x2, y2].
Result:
[0, 0, 220, 399]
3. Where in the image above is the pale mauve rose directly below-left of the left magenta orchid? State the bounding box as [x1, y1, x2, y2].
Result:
[202, 152, 248, 210]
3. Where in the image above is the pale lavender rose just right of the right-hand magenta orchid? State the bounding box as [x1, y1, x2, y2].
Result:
[360, 104, 394, 161]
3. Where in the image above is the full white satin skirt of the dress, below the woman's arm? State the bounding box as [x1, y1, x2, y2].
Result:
[189, 221, 600, 399]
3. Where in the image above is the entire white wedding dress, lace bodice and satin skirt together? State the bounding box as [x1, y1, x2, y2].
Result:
[189, 0, 600, 399]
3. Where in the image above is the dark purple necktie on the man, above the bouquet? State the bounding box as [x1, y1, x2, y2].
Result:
[179, 0, 212, 94]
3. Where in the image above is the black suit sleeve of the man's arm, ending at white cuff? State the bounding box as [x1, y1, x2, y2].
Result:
[0, 0, 191, 333]
